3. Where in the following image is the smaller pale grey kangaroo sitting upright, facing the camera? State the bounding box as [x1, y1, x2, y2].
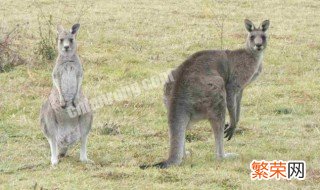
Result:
[40, 24, 93, 166]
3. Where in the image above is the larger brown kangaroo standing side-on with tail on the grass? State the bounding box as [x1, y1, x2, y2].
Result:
[140, 19, 269, 169]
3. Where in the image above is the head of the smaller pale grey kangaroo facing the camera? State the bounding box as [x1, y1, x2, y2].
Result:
[57, 24, 80, 56]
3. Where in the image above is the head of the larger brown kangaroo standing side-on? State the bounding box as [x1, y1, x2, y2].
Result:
[244, 19, 270, 52]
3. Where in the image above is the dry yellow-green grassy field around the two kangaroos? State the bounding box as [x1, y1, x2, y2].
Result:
[0, 0, 320, 189]
